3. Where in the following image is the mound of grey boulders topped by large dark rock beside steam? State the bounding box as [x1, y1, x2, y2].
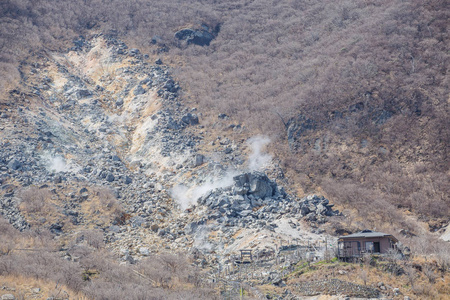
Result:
[198, 172, 339, 230]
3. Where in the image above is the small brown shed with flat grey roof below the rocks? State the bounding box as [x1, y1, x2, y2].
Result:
[338, 229, 398, 260]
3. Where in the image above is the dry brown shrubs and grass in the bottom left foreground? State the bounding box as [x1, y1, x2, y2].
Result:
[0, 218, 217, 299]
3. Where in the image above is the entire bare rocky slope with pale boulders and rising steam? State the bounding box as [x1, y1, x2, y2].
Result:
[1, 34, 339, 261]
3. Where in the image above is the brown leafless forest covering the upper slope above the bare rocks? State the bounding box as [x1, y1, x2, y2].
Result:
[0, 0, 450, 230]
